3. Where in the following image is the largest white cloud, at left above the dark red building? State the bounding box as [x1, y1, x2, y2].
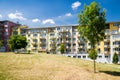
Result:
[8, 12, 27, 20]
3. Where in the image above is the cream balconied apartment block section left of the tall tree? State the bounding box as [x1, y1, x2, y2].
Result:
[26, 26, 85, 53]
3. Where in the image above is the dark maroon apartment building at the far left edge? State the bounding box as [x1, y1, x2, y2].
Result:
[0, 20, 18, 51]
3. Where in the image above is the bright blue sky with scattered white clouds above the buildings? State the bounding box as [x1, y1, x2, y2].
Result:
[0, 0, 120, 27]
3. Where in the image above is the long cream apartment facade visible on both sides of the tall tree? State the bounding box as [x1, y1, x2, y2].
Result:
[26, 22, 120, 62]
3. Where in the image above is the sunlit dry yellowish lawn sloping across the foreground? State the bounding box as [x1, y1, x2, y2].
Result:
[0, 53, 120, 80]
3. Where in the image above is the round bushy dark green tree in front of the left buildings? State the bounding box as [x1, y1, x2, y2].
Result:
[8, 35, 27, 50]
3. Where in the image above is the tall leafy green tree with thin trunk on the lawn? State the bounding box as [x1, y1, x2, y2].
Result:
[78, 2, 106, 72]
